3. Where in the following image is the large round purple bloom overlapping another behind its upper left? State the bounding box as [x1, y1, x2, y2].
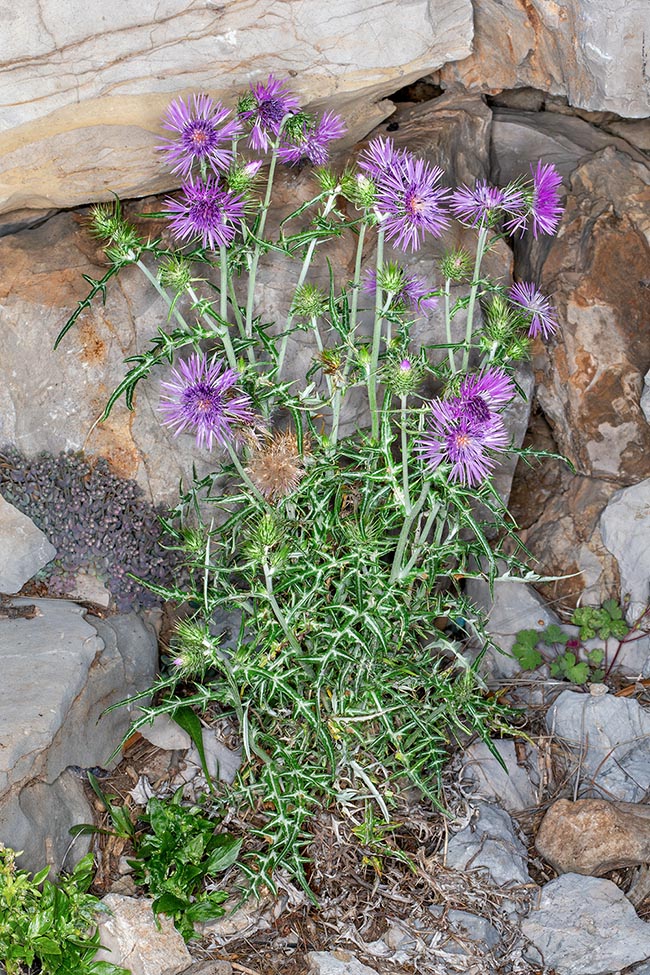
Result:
[377, 153, 449, 250]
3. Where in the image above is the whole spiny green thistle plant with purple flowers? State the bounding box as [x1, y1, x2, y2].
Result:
[58, 77, 561, 889]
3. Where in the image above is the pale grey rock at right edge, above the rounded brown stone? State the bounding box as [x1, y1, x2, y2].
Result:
[546, 691, 650, 802]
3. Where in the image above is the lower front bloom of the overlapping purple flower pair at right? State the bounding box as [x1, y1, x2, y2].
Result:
[416, 400, 508, 487]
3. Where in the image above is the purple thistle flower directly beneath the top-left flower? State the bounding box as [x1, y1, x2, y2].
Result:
[165, 176, 244, 250]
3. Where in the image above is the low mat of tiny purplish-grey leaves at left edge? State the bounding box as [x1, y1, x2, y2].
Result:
[0, 447, 178, 612]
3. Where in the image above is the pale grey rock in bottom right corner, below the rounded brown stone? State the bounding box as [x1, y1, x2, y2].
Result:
[522, 873, 650, 975]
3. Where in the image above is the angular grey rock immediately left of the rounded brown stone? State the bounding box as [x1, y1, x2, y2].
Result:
[447, 802, 531, 887]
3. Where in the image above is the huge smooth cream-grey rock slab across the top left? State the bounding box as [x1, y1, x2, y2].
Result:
[0, 0, 472, 212]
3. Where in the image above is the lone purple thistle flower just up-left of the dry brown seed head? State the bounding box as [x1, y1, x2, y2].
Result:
[159, 353, 255, 450]
